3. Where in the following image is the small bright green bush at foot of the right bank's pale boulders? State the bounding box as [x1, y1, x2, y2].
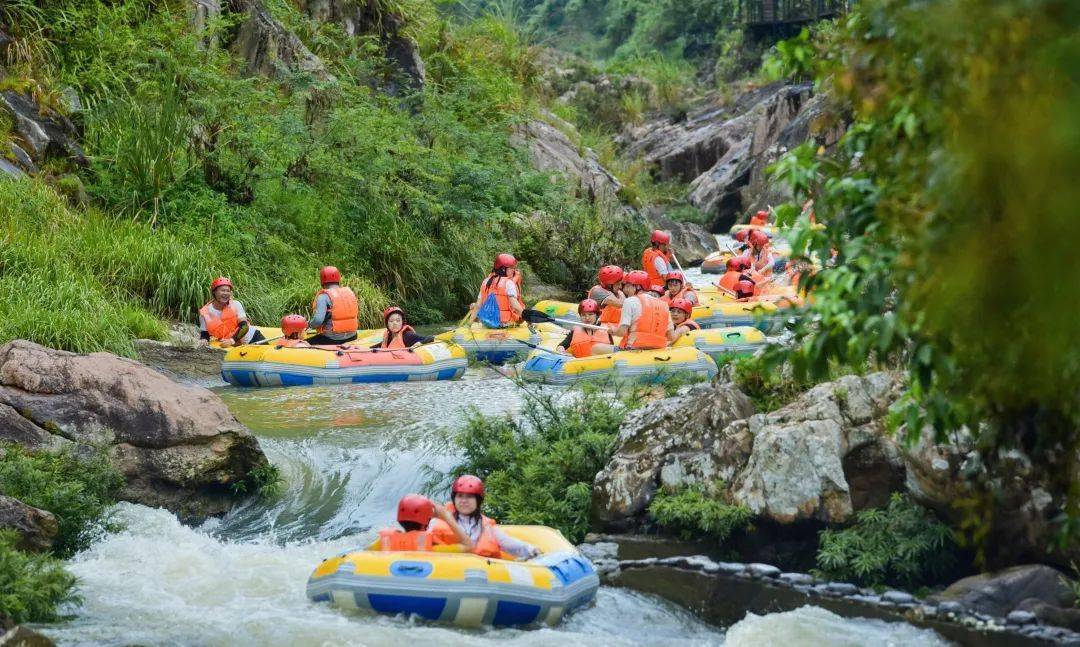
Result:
[649, 484, 754, 543]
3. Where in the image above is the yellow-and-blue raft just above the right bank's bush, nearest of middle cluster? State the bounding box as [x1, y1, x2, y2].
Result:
[519, 346, 717, 385]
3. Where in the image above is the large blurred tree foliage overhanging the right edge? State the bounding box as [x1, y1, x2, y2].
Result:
[775, 0, 1080, 557]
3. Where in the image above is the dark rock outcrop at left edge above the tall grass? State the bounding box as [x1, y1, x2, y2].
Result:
[0, 90, 89, 172]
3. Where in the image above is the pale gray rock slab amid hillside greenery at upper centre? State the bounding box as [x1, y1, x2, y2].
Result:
[511, 116, 622, 202]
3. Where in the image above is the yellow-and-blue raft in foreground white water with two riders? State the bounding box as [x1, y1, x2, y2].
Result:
[308, 525, 599, 626]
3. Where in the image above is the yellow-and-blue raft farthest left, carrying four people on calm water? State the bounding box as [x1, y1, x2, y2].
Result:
[221, 341, 469, 387]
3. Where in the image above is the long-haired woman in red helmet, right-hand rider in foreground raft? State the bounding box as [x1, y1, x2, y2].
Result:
[429, 474, 540, 560]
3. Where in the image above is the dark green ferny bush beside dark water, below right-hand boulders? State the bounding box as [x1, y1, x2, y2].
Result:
[818, 494, 956, 588]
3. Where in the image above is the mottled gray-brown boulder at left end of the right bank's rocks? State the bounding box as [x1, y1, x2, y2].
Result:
[592, 385, 754, 529]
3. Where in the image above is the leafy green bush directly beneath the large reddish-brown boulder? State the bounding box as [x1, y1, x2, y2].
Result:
[0, 445, 123, 557]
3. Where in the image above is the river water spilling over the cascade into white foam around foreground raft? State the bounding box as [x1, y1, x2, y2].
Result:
[39, 265, 942, 646]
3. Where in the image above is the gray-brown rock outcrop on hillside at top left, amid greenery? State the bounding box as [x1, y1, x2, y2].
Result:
[229, 0, 334, 80]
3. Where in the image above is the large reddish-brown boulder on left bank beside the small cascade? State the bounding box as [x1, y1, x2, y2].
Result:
[0, 340, 266, 516]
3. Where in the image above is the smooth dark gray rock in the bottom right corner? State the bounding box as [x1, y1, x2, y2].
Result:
[933, 564, 1075, 617]
